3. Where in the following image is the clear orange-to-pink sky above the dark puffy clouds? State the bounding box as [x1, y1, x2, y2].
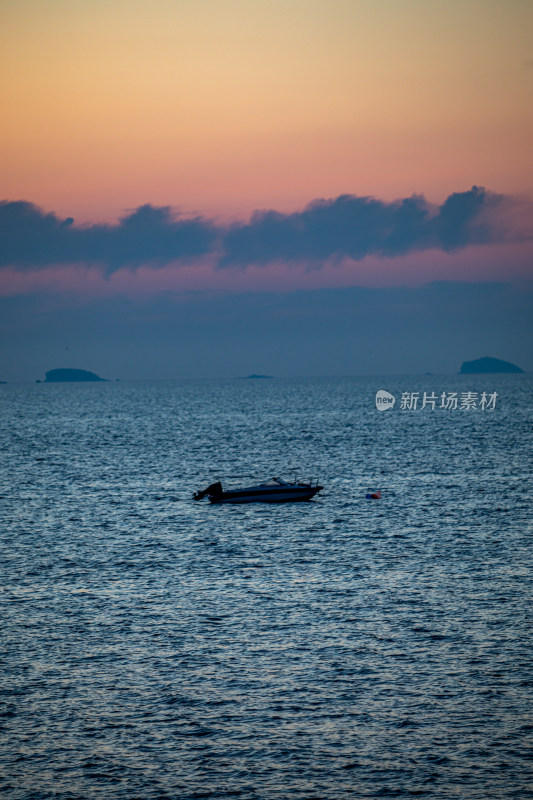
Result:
[0, 0, 533, 222]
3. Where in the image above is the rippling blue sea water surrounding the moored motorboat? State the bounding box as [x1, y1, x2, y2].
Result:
[0, 375, 533, 800]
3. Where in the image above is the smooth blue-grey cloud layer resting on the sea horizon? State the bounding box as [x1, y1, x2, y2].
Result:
[0, 282, 533, 380]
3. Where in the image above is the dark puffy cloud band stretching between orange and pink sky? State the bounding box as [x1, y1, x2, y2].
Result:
[0, 186, 532, 274]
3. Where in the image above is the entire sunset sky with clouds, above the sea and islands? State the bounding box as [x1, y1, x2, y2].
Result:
[0, 0, 533, 381]
